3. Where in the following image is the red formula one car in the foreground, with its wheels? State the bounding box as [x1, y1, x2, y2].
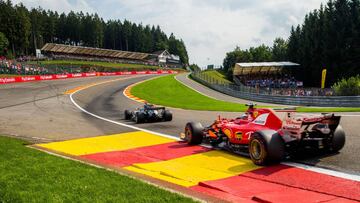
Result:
[181, 104, 345, 165]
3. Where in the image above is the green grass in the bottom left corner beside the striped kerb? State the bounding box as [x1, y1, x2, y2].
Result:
[0, 136, 194, 202]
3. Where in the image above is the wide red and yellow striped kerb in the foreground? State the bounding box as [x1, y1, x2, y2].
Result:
[36, 131, 360, 202]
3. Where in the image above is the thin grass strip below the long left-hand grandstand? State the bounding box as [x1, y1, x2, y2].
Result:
[29, 60, 159, 69]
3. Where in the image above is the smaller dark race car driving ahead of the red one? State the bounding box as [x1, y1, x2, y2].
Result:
[124, 104, 172, 123]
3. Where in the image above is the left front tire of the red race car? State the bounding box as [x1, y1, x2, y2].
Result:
[185, 122, 204, 145]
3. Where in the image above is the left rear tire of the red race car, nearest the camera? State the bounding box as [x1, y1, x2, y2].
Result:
[249, 130, 285, 166]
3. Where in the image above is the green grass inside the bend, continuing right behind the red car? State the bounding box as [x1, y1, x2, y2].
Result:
[131, 75, 360, 112]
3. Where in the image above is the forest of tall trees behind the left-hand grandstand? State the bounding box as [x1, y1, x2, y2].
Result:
[0, 0, 188, 64]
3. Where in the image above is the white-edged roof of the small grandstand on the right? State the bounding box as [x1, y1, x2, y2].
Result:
[234, 62, 300, 76]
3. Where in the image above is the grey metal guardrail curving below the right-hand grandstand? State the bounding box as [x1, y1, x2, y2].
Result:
[191, 75, 360, 107]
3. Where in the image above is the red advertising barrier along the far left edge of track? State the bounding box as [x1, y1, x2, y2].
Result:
[0, 70, 177, 84]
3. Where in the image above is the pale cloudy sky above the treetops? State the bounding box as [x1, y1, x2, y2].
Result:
[13, 0, 327, 67]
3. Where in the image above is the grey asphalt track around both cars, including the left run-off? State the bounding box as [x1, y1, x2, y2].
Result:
[0, 75, 360, 175]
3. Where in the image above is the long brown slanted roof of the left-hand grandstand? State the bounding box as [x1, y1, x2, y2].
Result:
[41, 43, 153, 60]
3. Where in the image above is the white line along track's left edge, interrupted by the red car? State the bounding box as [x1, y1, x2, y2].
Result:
[70, 75, 360, 181]
